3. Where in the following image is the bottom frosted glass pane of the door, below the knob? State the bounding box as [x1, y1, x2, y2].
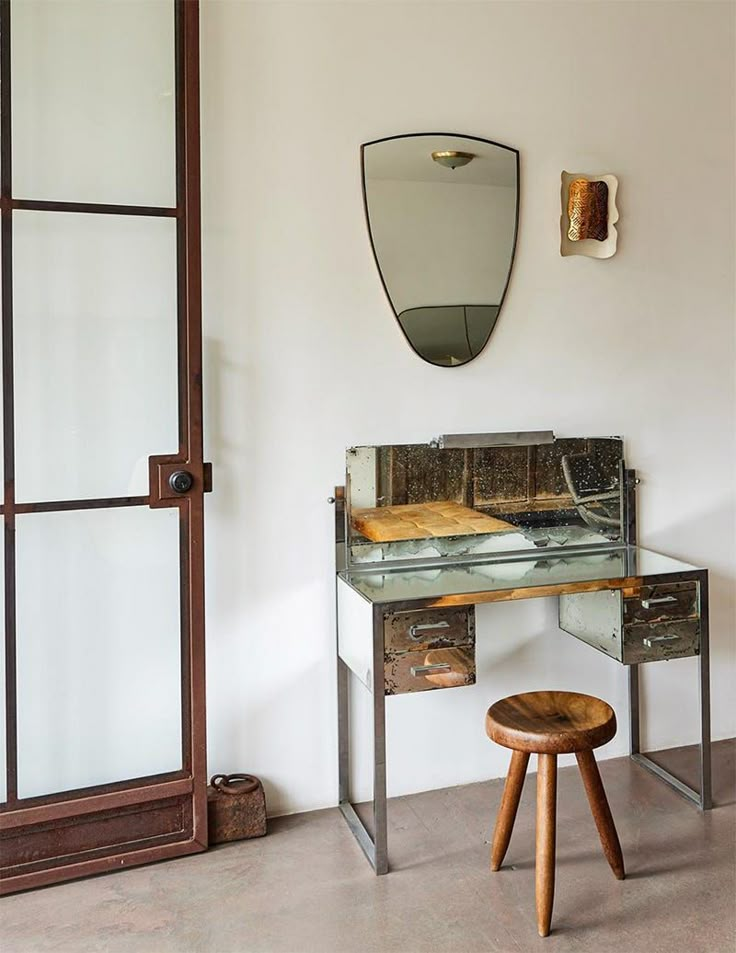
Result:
[16, 507, 182, 797]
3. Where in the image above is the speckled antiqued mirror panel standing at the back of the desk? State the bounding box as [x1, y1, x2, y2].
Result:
[347, 437, 623, 564]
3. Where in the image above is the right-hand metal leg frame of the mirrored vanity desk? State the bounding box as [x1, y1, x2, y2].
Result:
[629, 573, 713, 811]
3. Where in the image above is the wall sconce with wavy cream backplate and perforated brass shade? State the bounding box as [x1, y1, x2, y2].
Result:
[560, 172, 618, 258]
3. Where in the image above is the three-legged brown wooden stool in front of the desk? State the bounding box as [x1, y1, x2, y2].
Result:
[486, 692, 624, 936]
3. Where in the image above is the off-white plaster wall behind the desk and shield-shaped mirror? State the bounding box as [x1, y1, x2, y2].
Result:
[202, 0, 736, 813]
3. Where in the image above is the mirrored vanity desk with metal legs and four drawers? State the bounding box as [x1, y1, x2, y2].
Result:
[331, 432, 711, 874]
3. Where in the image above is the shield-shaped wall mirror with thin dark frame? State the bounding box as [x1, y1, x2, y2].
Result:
[361, 133, 519, 367]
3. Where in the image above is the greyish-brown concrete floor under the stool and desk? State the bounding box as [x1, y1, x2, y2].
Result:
[0, 741, 736, 953]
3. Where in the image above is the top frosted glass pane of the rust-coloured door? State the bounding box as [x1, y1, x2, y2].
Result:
[11, 0, 176, 206]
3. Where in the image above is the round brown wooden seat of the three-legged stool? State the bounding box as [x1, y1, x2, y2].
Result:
[486, 692, 616, 754]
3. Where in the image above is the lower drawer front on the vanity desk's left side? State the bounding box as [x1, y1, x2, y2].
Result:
[385, 645, 475, 695]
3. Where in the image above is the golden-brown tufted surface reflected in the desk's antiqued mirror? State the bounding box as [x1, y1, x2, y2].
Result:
[352, 500, 516, 543]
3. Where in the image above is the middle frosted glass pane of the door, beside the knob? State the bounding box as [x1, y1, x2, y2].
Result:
[13, 212, 179, 502]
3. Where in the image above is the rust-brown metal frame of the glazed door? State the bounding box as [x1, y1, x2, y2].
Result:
[0, 0, 210, 893]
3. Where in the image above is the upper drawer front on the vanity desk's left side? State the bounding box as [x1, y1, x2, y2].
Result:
[383, 606, 475, 652]
